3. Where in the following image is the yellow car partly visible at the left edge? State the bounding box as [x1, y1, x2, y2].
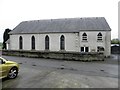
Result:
[0, 57, 19, 79]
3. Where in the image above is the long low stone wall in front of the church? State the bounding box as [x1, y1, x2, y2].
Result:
[2, 50, 104, 61]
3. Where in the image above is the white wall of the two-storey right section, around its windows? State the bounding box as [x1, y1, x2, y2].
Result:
[79, 31, 111, 56]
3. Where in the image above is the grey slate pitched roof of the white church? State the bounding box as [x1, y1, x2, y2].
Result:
[9, 17, 111, 34]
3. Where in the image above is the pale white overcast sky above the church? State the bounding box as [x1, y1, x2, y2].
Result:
[0, 0, 119, 42]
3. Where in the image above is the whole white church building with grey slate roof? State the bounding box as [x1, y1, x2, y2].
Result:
[8, 17, 111, 56]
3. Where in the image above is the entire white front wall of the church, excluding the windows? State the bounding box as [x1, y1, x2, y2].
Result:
[10, 31, 111, 56]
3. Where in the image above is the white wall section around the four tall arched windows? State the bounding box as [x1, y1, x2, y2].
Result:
[10, 33, 76, 51]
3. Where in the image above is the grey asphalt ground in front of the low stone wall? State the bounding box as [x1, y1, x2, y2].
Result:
[2, 55, 120, 88]
